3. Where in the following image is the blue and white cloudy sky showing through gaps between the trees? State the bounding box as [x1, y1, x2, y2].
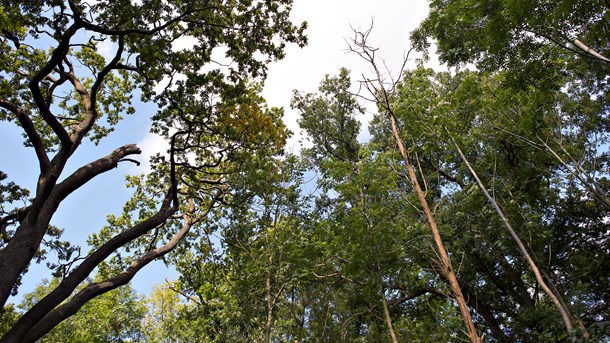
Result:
[0, 0, 436, 303]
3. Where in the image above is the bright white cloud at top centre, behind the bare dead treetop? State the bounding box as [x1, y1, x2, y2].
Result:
[263, 0, 436, 151]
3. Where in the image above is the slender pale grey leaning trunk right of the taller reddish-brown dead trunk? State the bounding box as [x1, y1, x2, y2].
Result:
[451, 137, 589, 340]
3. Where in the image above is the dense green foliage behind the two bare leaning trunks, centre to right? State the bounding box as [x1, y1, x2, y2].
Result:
[140, 63, 609, 342]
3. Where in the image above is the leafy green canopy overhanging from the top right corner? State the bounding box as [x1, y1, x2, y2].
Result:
[411, 0, 610, 74]
